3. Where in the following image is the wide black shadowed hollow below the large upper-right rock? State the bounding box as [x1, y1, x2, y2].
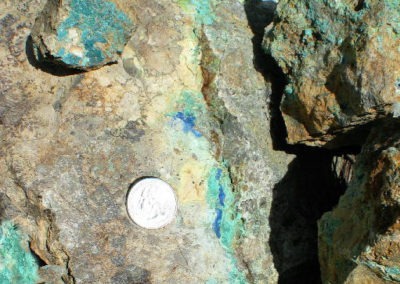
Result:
[269, 149, 353, 284]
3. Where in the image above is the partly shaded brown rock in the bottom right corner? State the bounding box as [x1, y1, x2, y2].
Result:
[319, 121, 400, 283]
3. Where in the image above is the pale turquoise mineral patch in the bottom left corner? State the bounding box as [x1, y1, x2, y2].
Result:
[0, 222, 38, 284]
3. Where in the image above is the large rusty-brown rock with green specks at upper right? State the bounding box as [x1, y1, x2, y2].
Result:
[264, 0, 400, 148]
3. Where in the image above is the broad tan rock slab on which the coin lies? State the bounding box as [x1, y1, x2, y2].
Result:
[0, 0, 298, 283]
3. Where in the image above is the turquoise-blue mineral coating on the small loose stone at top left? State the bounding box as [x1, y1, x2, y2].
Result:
[56, 0, 133, 67]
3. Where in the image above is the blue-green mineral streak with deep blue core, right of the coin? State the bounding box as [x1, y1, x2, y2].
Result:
[207, 165, 247, 284]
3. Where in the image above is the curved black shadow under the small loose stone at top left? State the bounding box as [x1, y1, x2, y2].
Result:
[25, 36, 85, 77]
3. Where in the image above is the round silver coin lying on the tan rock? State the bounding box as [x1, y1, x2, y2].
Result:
[126, 178, 177, 229]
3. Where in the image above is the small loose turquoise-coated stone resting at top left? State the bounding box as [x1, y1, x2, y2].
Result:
[32, 0, 134, 70]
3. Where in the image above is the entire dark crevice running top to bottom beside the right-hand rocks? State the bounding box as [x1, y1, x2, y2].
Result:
[245, 0, 360, 284]
